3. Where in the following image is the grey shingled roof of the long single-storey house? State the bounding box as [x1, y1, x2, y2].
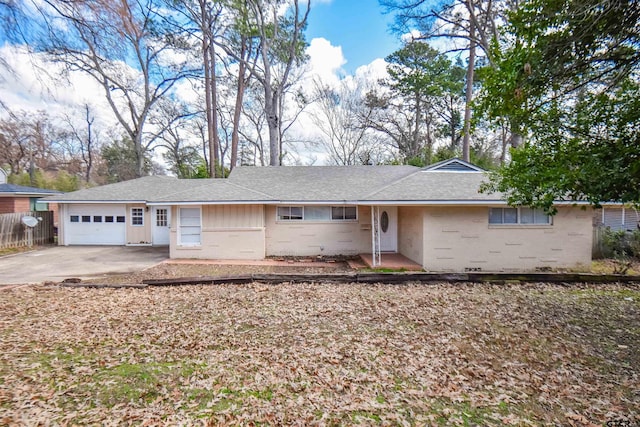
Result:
[43, 159, 501, 204]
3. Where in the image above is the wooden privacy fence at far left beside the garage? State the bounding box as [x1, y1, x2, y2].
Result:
[0, 211, 54, 249]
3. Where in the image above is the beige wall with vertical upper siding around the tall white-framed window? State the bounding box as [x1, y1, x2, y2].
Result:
[169, 205, 265, 260]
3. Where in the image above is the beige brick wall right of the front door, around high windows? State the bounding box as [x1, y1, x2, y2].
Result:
[423, 207, 593, 272]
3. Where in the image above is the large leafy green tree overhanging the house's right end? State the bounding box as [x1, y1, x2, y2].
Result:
[477, 0, 640, 211]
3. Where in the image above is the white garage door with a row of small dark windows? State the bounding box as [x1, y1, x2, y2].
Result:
[64, 205, 127, 245]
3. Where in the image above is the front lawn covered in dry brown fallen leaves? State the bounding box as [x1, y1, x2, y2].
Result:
[0, 283, 640, 425]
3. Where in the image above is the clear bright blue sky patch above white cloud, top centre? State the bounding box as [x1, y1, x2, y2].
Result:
[306, 0, 400, 74]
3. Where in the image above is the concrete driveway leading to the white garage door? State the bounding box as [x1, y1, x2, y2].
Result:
[0, 246, 169, 285]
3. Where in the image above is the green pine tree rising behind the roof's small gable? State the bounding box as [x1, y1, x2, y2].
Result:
[365, 41, 464, 166]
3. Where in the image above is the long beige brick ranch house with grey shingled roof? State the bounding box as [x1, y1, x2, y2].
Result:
[49, 159, 592, 271]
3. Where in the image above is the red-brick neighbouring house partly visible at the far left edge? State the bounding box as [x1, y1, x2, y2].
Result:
[0, 183, 62, 223]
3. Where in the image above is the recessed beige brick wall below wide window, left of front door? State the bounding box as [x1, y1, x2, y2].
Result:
[265, 206, 371, 256]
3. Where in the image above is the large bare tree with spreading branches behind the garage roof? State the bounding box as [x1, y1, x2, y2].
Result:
[33, 0, 193, 176]
